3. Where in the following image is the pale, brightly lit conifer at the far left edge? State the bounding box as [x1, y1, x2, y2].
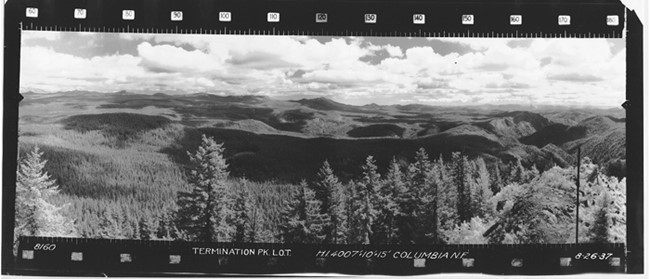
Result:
[14, 146, 77, 240]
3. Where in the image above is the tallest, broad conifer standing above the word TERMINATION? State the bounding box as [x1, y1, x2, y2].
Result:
[177, 135, 234, 242]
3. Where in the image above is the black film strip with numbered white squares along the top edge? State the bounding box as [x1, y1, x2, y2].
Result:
[12, 0, 626, 38]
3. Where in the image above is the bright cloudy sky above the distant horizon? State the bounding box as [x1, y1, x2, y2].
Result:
[21, 31, 625, 107]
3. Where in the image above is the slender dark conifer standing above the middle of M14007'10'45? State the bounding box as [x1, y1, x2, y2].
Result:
[351, 156, 380, 244]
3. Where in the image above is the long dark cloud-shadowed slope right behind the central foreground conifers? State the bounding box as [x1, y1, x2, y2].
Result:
[164, 128, 501, 183]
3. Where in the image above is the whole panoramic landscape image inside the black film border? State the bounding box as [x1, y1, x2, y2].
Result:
[15, 31, 626, 245]
